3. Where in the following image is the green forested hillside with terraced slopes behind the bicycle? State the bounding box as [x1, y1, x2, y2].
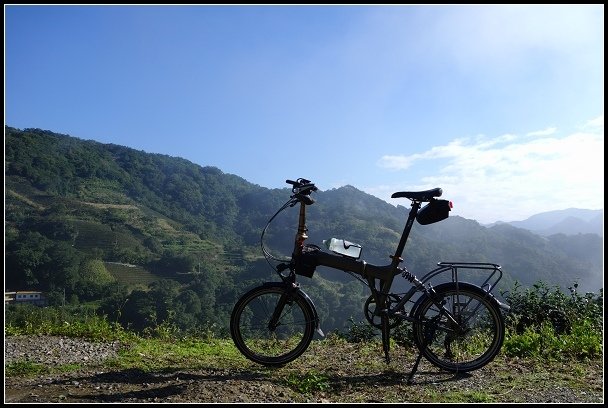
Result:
[5, 127, 603, 330]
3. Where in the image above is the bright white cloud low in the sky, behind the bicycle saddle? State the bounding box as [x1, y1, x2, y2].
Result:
[366, 116, 604, 222]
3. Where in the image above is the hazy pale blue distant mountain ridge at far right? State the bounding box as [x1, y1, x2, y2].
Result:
[486, 208, 604, 237]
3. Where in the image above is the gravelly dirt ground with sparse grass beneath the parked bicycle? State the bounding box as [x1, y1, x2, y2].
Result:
[4, 338, 604, 404]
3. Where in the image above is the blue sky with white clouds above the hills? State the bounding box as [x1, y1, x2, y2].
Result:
[4, 5, 604, 223]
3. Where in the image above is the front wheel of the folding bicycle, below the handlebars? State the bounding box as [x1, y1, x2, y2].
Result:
[230, 284, 317, 366]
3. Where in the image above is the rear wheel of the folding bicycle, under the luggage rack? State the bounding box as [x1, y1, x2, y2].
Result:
[413, 282, 505, 372]
